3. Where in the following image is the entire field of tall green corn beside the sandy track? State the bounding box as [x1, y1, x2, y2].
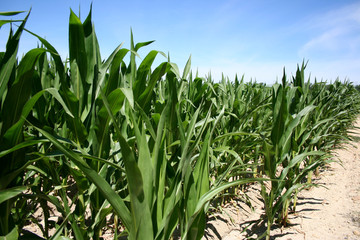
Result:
[0, 7, 360, 240]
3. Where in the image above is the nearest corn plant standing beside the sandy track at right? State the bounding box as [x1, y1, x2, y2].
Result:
[261, 66, 324, 239]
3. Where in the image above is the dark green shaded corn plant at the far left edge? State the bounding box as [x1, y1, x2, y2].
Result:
[0, 11, 76, 237]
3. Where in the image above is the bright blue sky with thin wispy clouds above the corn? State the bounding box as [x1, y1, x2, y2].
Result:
[0, 0, 360, 85]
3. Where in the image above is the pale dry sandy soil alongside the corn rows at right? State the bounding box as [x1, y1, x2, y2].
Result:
[203, 118, 360, 240]
